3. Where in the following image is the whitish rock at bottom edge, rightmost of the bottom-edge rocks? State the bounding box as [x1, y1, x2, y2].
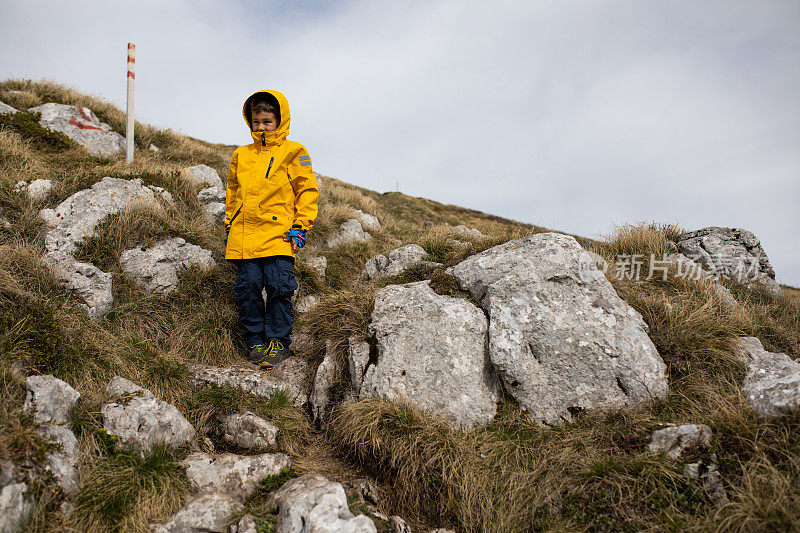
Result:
[271, 474, 377, 533]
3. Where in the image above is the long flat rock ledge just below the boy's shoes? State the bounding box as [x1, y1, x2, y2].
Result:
[189, 357, 308, 407]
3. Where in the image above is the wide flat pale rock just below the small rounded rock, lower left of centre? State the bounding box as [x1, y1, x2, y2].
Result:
[183, 452, 291, 499]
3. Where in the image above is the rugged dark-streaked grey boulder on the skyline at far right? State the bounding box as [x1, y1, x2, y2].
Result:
[677, 226, 783, 296]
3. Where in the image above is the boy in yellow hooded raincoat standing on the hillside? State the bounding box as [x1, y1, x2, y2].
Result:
[225, 91, 319, 369]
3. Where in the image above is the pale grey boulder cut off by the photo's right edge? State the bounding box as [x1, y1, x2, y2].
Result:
[735, 337, 800, 416]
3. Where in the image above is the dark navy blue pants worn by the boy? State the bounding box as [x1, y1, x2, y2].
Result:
[233, 255, 297, 346]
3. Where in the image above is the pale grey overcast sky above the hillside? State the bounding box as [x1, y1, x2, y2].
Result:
[0, 0, 800, 286]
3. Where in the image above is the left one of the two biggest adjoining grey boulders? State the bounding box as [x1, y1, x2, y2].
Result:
[354, 281, 497, 428]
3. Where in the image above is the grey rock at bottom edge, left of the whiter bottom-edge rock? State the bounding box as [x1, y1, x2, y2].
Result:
[154, 493, 244, 533]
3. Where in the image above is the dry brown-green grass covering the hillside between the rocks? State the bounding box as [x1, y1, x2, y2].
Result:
[0, 80, 800, 531]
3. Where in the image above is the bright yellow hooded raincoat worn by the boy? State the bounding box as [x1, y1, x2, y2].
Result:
[225, 91, 319, 259]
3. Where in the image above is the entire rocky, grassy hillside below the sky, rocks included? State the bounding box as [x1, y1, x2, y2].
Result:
[0, 80, 800, 532]
